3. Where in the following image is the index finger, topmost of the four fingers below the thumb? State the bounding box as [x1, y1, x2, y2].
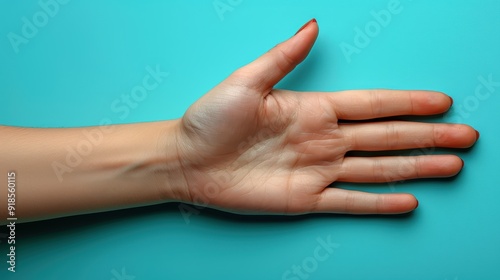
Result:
[329, 89, 453, 120]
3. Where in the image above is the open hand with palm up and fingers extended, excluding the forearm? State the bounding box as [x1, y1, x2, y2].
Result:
[177, 20, 478, 214]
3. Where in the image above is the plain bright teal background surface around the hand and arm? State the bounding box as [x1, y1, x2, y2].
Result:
[0, 0, 500, 280]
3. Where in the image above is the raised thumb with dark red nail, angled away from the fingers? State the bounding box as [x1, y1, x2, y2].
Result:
[229, 19, 319, 95]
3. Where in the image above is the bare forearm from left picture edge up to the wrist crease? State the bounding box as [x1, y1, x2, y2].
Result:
[0, 121, 185, 223]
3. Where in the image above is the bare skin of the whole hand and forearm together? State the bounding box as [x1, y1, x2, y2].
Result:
[0, 21, 479, 221]
